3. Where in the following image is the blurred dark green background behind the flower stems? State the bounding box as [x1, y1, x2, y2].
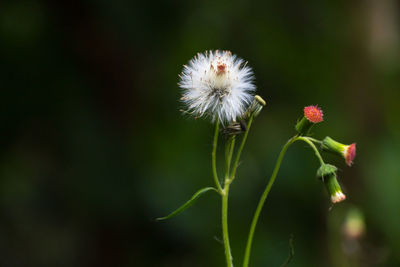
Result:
[0, 0, 400, 266]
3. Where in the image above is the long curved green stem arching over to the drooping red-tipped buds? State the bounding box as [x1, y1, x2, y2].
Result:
[243, 135, 325, 267]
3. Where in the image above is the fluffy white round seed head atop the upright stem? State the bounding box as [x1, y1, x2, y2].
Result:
[179, 50, 256, 124]
